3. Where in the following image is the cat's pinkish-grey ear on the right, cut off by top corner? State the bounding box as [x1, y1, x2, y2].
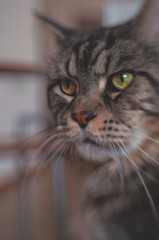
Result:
[137, 0, 159, 41]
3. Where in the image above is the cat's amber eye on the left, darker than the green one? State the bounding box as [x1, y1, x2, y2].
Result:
[60, 79, 77, 96]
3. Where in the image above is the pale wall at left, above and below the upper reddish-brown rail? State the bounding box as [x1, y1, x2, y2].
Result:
[0, 0, 46, 140]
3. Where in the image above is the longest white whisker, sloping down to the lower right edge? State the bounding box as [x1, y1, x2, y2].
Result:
[117, 138, 159, 222]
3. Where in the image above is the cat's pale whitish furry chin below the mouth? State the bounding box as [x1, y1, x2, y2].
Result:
[76, 141, 112, 162]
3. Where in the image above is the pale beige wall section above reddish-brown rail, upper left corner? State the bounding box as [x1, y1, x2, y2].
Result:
[0, 0, 36, 63]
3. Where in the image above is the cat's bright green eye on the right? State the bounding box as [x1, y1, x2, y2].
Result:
[112, 72, 134, 90]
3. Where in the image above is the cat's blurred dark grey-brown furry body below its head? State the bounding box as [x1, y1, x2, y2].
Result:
[79, 162, 159, 240]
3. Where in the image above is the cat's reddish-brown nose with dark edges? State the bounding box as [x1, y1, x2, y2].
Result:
[72, 113, 96, 128]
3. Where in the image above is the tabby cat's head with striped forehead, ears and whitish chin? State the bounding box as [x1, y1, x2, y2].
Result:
[38, 1, 159, 167]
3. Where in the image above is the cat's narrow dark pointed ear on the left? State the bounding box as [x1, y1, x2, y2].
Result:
[35, 11, 75, 40]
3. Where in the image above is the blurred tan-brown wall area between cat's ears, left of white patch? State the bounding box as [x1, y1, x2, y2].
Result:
[41, 0, 105, 29]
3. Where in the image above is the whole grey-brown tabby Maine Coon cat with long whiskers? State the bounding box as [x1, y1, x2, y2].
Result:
[39, 0, 159, 240]
